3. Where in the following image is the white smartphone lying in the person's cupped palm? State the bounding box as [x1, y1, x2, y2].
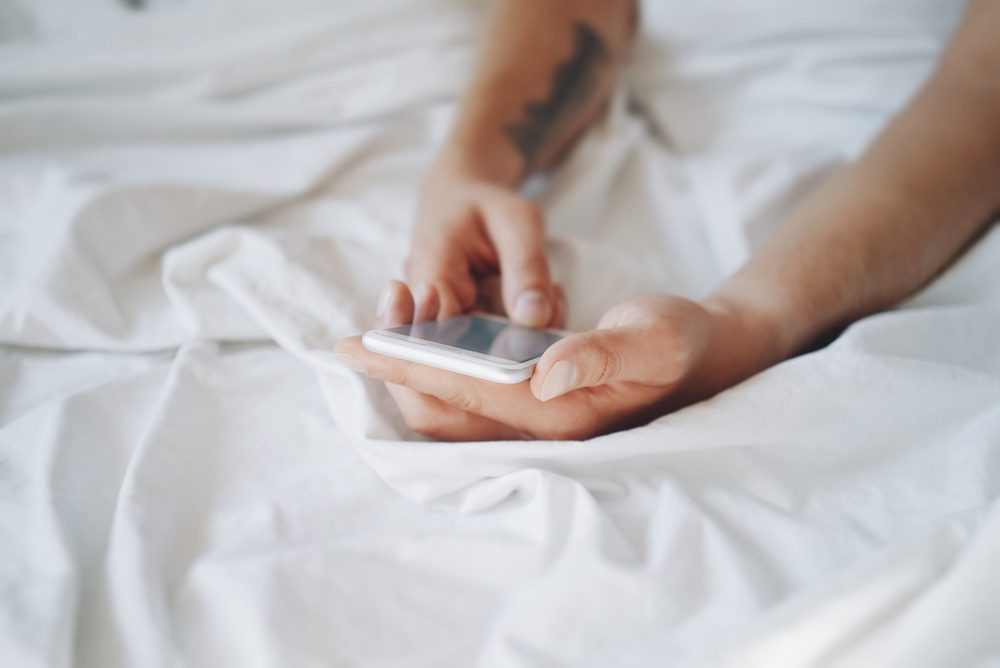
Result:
[361, 313, 569, 384]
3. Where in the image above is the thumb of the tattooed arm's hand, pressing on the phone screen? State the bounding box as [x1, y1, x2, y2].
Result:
[483, 190, 556, 327]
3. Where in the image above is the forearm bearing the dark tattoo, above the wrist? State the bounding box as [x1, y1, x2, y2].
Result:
[439, 0, 635, 185]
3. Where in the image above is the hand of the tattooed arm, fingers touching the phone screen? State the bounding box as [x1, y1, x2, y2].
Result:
[405, 161, 562, 327]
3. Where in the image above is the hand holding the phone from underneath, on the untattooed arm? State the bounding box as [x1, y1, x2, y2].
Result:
[336, 284, 776, 440]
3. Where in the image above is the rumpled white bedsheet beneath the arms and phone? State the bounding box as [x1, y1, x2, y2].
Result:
[0, 0, 1000, 667]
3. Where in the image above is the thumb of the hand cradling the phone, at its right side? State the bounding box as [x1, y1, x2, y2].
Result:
[531, 325, 690, 401]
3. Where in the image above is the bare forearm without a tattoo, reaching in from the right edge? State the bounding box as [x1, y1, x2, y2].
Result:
[708, 3, 1000, 372]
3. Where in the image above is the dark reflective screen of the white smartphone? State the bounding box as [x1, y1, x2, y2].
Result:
[388, 315, 562, 362]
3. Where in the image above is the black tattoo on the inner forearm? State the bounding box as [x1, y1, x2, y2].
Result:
[504, 22, 611, 172]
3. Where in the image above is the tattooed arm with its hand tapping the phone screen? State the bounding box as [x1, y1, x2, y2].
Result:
[406, 0, 635, 326]
